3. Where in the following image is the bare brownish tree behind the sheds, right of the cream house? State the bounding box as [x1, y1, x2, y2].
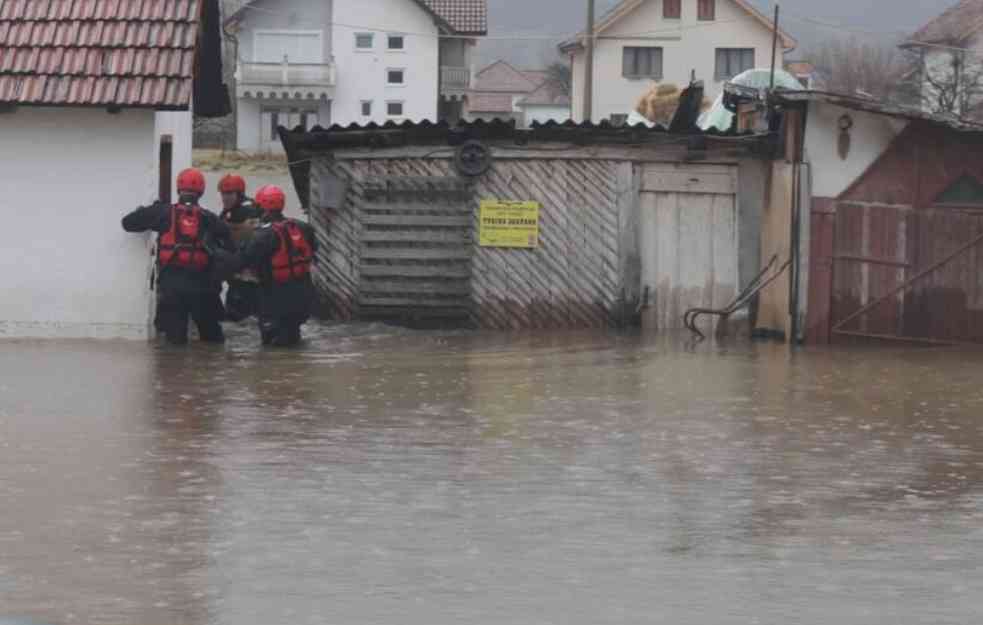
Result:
[806, 38, 907, 100]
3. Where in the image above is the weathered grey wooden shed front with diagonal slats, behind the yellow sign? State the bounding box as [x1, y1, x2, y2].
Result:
[310, 144, 764, 330]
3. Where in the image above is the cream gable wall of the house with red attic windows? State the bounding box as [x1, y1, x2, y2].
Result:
[573, 0, 784, 122]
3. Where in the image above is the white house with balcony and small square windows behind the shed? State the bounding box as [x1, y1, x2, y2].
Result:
[227, 0, 487, 152]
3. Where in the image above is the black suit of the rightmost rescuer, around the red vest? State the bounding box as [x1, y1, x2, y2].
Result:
[236, 217, 318, 318]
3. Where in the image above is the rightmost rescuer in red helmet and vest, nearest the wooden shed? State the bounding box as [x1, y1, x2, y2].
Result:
[236, 185, 317, 347]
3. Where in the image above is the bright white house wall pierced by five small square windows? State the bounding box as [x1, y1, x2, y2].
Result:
[332, 0, 439, 125]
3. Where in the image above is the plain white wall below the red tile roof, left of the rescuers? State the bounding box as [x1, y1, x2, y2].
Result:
[0, 107, 157, 338]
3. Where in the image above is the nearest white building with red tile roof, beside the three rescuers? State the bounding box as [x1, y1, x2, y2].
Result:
[0, 0, 228, 338]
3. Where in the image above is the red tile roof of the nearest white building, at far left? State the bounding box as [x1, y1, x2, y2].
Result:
[0, 0, 203, 109]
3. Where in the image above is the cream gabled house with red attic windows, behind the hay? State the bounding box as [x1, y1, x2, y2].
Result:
[560, 0, 795, 122]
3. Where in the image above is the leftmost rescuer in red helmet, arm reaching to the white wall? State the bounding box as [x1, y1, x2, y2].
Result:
[123, 169, 232, 345]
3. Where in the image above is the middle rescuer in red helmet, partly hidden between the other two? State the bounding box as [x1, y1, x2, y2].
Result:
[218, 174, 263, 322]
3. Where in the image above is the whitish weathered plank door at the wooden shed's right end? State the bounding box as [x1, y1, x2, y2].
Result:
[640, 163, 739, 330]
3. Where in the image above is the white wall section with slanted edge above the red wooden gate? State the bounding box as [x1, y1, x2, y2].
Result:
[805, 102, 907, 197]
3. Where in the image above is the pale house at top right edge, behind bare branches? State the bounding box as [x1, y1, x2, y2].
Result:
[901, 0, 983, 116]
